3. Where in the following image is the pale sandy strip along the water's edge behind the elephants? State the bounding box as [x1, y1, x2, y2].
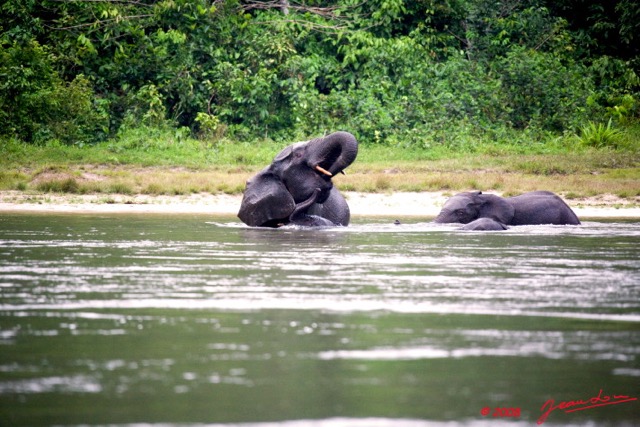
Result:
[0, 191, 640, 219]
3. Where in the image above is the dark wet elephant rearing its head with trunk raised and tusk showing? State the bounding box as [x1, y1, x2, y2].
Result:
[238, 131, 358, 228]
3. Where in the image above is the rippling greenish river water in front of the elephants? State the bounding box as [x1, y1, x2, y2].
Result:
[0, 214, 640, 427]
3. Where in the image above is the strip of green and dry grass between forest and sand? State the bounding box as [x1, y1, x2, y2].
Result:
[0, 125, 640, 201]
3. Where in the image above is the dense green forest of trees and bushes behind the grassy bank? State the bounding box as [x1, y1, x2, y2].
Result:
[0, 0, 640, 148]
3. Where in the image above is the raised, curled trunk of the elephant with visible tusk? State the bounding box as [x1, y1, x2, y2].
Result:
[307, 132, 358, 176]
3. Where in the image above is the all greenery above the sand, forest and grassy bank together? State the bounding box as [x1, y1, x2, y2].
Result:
[0, 0, 640, 201]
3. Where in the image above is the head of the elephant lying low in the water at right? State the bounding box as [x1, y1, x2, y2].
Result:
[434, 191, 515, 224]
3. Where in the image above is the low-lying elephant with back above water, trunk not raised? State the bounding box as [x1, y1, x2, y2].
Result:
[434, 191, 580, 230]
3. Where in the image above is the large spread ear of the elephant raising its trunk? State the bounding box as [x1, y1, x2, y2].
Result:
[238, 170, 295, 227]
